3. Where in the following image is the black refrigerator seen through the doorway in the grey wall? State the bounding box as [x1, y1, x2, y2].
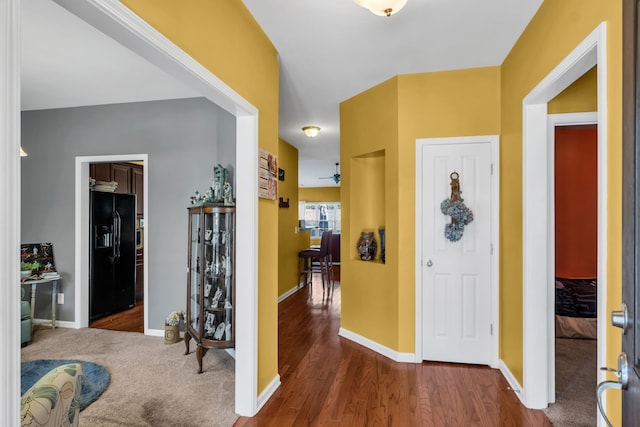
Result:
[89, 191, 136, 320]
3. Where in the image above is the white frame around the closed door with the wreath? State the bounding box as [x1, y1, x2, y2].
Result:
[415, 135, 500, 368]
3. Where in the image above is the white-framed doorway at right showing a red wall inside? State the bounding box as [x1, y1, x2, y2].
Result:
[545, 117, 598, 425]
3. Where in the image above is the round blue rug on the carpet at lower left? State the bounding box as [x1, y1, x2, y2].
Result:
[20, 359, 111, 411]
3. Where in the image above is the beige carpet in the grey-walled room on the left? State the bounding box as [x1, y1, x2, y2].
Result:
[22, 328, 238, 427]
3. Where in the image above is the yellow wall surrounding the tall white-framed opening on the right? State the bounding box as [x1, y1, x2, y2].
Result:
[500, 0, 622, 425]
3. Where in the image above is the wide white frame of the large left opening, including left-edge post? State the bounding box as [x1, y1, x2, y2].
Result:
[0, 0, 259, 425]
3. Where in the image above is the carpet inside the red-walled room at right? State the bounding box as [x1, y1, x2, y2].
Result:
[544, 338, 598, 427]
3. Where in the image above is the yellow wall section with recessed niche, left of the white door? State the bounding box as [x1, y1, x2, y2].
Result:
[340, 78, 399, 349]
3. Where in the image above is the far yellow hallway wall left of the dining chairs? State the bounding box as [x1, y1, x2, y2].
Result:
[278, 139, 309, 295]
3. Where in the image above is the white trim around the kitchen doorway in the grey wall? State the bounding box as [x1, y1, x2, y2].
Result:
[74, 154, 148, 335]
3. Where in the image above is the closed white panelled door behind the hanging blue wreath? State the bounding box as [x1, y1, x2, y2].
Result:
[418, 142, 492, 364]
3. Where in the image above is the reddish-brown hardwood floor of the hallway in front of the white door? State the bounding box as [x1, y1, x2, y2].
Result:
[235, 279, 551, 427]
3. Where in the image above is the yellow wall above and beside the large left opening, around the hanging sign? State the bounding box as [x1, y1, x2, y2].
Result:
[123, 0, 279, 393]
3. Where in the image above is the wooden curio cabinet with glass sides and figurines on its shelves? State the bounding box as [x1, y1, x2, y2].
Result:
[184, 204, 235, 373]
